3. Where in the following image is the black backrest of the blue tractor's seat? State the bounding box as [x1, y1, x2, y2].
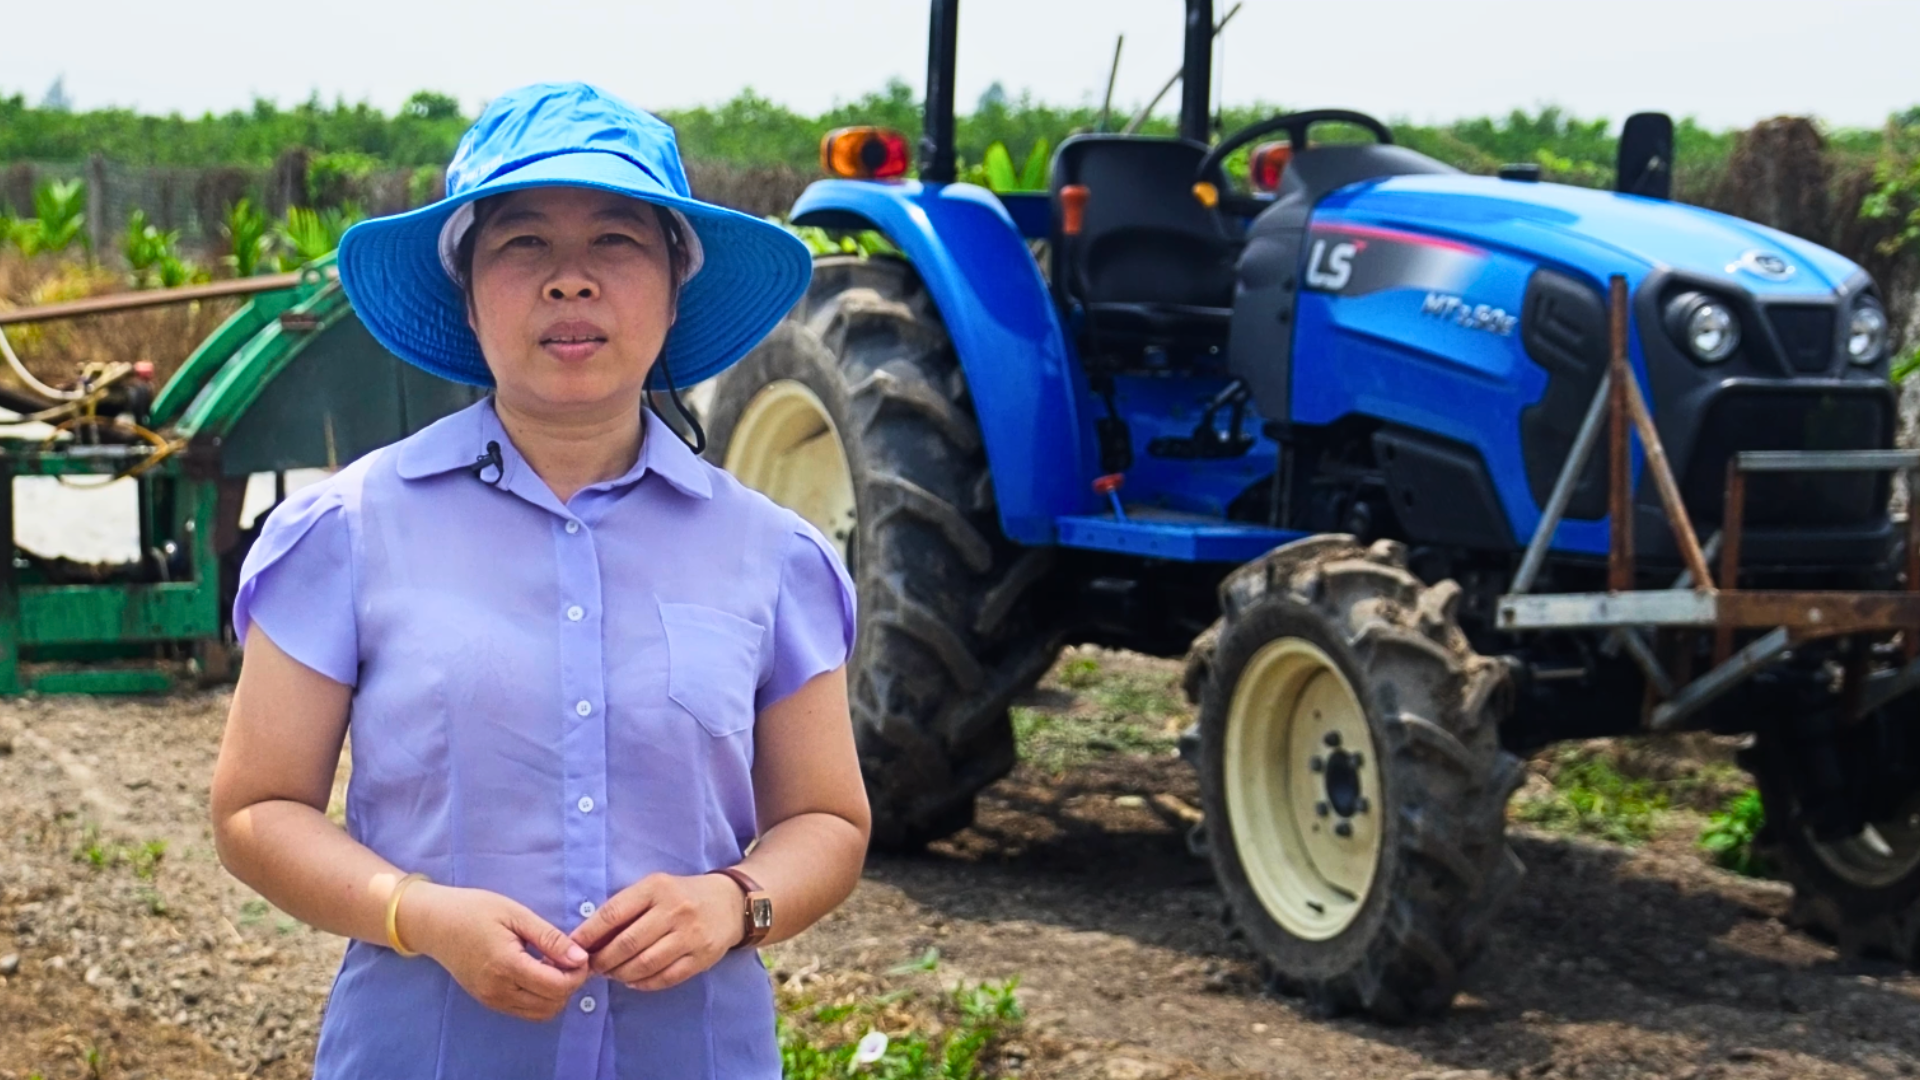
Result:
[1050, 135, 1238, 307]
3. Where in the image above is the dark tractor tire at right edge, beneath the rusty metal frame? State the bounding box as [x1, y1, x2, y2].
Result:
[1741, 722, 1920, 967]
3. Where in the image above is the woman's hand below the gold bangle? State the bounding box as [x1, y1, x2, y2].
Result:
[396, 882, 591, 1022]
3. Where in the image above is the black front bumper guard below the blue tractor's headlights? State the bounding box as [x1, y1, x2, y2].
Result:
[1680, 386, 1893, 536]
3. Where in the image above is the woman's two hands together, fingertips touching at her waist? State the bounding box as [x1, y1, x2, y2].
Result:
[397, 874, 745, 1022]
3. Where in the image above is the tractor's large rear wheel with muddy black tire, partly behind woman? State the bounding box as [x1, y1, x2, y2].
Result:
[705, 256, 1060, 851]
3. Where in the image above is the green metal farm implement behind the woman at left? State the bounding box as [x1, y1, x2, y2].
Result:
[0, 259, 478, 694]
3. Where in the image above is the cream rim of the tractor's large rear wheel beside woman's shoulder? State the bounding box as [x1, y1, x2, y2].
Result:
[722, 379, 858, 559]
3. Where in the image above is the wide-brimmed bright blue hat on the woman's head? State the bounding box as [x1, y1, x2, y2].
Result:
[338, 83, 812, 390]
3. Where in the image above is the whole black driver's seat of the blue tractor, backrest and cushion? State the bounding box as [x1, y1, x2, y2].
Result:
[1052, 135, 1240, 352]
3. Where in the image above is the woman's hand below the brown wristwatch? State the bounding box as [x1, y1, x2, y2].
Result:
[572, 874, 747, 990]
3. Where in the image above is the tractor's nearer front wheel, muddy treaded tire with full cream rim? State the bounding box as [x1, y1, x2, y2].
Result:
[1188, 536, 1523, 1022]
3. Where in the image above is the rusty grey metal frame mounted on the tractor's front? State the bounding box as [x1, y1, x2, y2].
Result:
[1496, 275, 1920, 732]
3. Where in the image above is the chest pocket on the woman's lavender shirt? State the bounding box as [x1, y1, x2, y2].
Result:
[660, 603, 760, 738]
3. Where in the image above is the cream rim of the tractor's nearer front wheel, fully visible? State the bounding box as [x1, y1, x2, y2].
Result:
[1223, 638, 1382, 942]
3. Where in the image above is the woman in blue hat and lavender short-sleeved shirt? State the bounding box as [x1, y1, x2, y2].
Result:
[213, 85, 868, 1080]
